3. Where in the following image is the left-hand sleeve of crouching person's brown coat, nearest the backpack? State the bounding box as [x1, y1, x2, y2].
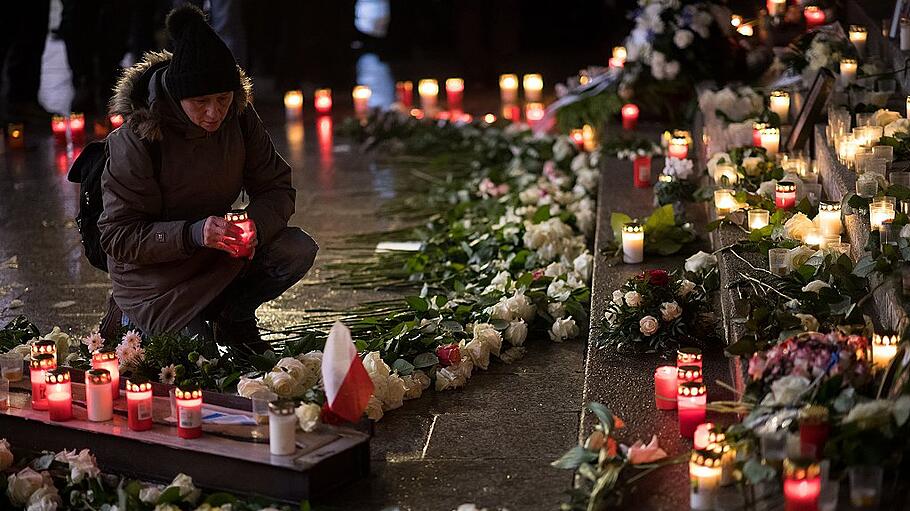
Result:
[98, 130, 194, 264]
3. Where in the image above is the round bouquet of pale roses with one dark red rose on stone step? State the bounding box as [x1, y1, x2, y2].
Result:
[600, 269, 707, 352]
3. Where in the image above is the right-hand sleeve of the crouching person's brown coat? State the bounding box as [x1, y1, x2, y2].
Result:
[240, 105, 297, 243]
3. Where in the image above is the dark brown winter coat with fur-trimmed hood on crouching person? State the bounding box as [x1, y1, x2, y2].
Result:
[98, 52, 295, 333]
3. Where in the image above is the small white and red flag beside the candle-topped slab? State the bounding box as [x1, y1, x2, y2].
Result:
[322, 322, 373, 422]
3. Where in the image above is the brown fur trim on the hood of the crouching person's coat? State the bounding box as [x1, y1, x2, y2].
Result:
[108, 51, 253, 141]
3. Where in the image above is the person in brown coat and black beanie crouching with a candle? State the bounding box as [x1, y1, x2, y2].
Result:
[98, 6, 318, 351]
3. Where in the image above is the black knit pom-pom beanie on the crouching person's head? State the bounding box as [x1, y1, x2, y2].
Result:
[165, 4, 240, 100]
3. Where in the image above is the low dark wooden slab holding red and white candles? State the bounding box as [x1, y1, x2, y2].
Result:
[0, 384, 369, 502]
